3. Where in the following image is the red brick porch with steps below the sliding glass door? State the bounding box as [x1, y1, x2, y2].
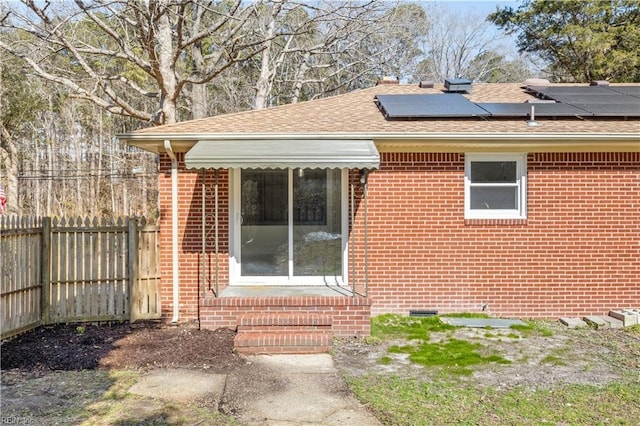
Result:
[200, 288, 371, 354]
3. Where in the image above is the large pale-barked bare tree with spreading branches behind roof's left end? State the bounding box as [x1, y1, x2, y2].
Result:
[0, 0, 270, 124]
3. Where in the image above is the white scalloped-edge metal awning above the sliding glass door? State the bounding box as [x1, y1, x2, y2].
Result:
[185, 139, 380, 169]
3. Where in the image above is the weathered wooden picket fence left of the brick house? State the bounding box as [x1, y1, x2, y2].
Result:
[0, 217, 161, 339]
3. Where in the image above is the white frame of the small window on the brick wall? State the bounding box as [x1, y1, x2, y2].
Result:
[464, 153, 527, 219]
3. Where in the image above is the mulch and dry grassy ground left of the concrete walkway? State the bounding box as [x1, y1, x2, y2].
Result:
[0, 322, 247, 425]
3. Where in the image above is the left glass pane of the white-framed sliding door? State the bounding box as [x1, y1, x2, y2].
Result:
[240, 169, 289, 276]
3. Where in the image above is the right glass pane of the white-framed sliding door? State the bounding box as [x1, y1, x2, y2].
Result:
[293, 169, 342, 276]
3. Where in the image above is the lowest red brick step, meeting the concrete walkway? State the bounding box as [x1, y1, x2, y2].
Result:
[233, 330, 332, 355]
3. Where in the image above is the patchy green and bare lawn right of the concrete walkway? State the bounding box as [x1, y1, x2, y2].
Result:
[334, 315, 640, 425]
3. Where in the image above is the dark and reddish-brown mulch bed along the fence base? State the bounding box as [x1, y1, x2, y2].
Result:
[0, 322, 245, 373]
